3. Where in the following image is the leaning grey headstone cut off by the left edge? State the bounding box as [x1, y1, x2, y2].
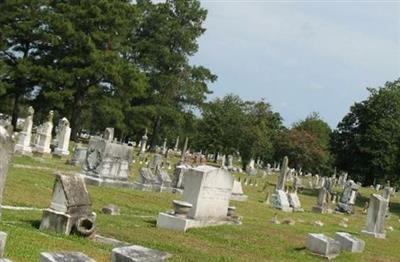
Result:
[0, 126, 14, 217]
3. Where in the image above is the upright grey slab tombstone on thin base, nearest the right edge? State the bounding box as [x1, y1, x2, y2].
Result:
[361, 194, 388, 238]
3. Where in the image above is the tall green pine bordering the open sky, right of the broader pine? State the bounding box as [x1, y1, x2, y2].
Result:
[132, 0, 216, 147]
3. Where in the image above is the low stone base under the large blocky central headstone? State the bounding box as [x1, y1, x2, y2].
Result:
[157, 213, 241, 232]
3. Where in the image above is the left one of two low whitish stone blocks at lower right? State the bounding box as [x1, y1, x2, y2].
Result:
[306, 233, 340, 259]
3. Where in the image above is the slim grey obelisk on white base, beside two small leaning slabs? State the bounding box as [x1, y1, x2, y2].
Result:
[271, 156, 293, 212]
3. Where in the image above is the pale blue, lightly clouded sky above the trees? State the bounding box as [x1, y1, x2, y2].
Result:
[191, 0, 400, 128]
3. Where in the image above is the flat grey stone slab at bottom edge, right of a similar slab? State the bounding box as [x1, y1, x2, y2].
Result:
[111, 245, 171, 262]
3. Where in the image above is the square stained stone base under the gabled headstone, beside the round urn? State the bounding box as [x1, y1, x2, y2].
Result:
[39, 208, 73, 235]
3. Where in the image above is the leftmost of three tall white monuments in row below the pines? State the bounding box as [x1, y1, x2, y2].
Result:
[14, 106, 35, 155]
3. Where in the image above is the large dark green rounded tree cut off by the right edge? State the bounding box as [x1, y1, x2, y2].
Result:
[332, 79, 400, 185]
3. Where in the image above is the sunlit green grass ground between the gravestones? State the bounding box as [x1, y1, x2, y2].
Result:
[0, 156, 400, 261]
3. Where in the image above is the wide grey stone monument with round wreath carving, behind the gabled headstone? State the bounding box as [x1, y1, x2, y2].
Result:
[82, 137, 132, 182]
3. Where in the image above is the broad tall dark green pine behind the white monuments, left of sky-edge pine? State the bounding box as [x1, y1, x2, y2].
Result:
[37, 0, 145, 138]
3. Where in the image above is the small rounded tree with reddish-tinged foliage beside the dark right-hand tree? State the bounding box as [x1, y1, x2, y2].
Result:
[276, 113, 332, 174]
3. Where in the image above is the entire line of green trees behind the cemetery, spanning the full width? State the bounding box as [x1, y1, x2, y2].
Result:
[0, 0, 400, 184]
